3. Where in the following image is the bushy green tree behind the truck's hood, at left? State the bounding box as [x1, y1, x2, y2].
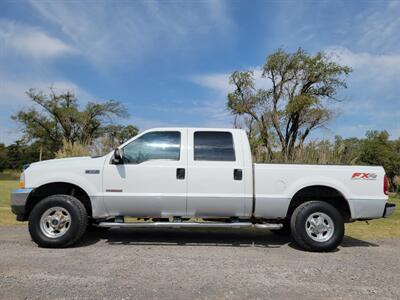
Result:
[12, 88, 128, 153]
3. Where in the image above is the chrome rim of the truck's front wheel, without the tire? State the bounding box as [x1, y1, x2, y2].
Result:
[40, 206, 71, 239]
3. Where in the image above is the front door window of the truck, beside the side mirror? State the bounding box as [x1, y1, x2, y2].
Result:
[123, 131, 181, 164]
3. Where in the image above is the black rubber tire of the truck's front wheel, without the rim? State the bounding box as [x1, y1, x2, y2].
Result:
[29, 195, 88, 248]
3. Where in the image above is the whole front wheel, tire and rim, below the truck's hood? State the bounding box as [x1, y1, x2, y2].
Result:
[29, 195, 88, 248]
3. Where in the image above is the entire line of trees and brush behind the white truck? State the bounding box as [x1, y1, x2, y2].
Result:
[0, 48, 400, 189]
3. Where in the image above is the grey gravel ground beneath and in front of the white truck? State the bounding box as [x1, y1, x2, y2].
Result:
[0, 226, 400, 299]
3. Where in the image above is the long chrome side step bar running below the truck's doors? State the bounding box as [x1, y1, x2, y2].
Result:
[97, 222, 282, 229]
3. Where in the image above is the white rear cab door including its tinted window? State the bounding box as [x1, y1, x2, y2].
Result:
[187, 129, 245, 217]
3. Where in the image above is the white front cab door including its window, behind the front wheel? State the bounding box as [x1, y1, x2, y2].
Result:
[103, 129, 187, 217]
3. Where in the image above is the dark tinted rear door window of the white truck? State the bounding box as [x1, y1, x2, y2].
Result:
[194, 131, 235, 161]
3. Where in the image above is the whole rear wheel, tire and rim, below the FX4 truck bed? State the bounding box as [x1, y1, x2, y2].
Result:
[290, 201, 344, 252]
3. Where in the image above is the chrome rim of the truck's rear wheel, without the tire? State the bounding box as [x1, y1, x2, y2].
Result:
[306, 212, 335, 243]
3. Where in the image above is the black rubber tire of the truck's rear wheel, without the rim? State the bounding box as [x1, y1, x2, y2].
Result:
[290, 201, 344, 252]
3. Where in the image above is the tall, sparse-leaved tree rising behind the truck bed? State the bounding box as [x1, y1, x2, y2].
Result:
[227, 48, 351, 161]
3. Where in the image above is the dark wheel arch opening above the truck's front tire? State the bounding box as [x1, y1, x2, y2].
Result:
[24, 181, 93, 220]
